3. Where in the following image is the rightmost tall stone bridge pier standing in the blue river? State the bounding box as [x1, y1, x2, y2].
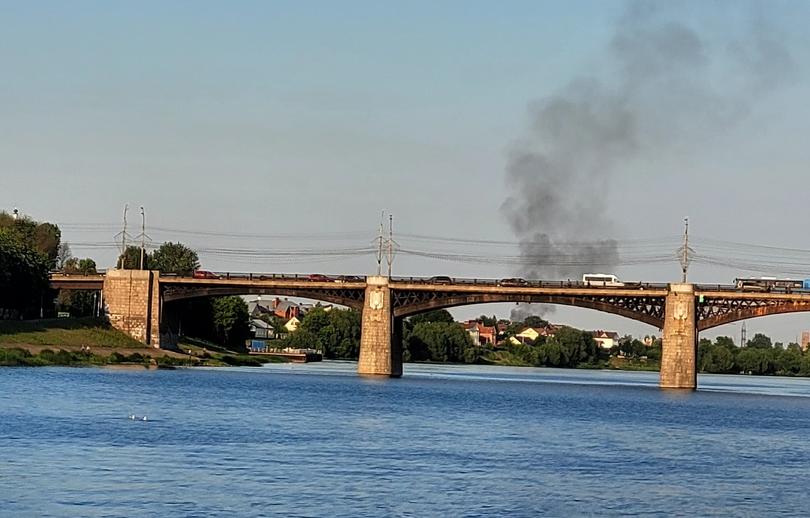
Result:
[659, 284, 697, 390]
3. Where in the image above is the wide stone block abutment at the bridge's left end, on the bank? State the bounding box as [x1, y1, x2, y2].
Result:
[104, 270, 161, 347]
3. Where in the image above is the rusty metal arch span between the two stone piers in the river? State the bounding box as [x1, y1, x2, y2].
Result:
[394, 293, 664, 329]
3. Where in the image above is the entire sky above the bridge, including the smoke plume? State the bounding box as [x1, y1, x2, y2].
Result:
[0, 0, 810, 342]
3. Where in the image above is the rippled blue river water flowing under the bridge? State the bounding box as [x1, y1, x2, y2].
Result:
[0, 362, 810, 517]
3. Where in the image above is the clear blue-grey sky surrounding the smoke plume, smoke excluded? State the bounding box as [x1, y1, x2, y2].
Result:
[0, 1, 810, 346]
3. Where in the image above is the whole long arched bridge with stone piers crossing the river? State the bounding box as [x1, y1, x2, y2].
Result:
[50, 270, 810, 389]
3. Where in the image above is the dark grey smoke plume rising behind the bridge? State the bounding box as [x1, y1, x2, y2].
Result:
[502, 2, 793, 318]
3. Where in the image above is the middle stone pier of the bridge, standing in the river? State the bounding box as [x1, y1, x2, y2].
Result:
[357, 276, 402, 377]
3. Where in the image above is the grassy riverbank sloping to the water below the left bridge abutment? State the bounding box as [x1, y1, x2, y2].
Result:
[0, 318, 283, 368]
